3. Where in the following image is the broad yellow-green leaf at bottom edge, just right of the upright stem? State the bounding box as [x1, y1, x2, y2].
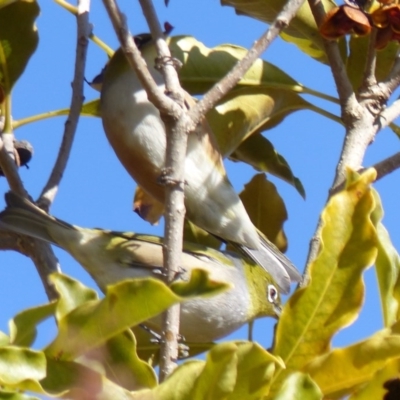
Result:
[138, 342, 284, 400]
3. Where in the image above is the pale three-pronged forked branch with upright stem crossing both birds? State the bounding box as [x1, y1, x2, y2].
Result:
[103, 0, 310, 380]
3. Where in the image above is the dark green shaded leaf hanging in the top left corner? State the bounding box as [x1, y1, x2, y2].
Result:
[0, 0, 39, 94]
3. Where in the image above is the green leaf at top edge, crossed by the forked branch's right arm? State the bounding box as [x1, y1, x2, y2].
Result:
[221, 0, 345, 62]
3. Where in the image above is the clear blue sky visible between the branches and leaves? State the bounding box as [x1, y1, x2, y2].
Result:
[0, 0, 400, 354]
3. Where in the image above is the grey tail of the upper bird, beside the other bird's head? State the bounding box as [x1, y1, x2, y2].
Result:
[240, 232, 302, 294]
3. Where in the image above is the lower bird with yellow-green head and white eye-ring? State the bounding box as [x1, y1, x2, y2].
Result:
[0, 192, 281, 343]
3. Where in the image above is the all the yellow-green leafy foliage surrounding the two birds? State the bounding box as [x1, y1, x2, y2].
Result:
[0, 0, 400, 400]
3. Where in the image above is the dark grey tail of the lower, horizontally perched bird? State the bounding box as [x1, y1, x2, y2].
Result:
[0, 192, 73, 245]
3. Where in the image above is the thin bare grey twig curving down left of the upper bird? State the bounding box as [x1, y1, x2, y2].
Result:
[38, 0, 91, 210]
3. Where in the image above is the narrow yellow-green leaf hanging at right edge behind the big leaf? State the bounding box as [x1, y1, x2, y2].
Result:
[371, 190, 400, 327]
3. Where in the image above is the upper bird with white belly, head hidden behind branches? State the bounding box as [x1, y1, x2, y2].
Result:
[98, 34, 302, 294]
